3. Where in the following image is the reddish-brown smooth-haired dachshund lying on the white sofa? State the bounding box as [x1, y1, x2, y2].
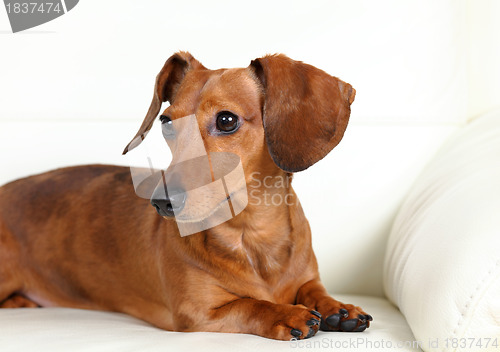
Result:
[0, 52, 372, 340]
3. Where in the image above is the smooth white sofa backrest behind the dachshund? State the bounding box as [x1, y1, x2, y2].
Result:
[0, 0, 500, 295]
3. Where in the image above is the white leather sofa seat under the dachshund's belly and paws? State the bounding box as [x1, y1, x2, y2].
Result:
[0, 295, 419, 352]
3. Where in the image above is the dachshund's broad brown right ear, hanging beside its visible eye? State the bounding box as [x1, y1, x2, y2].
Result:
[250, 55, 356, 172]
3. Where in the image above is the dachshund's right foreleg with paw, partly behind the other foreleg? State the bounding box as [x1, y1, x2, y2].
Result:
[297, 279, 373, 332]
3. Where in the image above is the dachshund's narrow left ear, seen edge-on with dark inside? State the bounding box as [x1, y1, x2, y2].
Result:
[123, 51, 205, 154]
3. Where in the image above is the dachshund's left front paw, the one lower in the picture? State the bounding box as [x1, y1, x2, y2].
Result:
[269, 305, 321, 340]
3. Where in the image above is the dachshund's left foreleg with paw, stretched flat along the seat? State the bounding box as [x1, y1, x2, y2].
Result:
[201, 298, 321, 341]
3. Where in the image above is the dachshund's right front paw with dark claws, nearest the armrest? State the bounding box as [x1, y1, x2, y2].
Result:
[319, 299, 373, 332]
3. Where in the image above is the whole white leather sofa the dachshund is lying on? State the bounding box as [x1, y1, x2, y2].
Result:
[0, 0, 500, 352]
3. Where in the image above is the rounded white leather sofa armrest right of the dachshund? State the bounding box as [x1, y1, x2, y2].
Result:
[384, 111, 500, 351]
